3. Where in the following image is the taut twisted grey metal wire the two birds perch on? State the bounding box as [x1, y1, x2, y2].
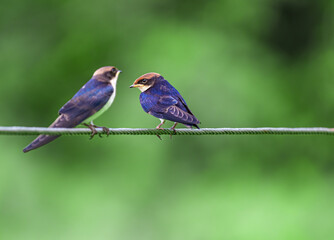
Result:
[0, 126, 334, 135]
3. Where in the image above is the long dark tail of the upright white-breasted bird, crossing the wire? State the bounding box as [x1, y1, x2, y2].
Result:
[23, 114, 75, 153]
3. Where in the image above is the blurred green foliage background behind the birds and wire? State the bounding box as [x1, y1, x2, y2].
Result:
[0, 0, 334, 240]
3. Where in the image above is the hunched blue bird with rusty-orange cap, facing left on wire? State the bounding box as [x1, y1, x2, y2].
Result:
[130, 73, 200, 131]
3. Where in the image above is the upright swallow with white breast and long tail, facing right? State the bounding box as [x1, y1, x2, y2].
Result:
[23, 66, 121, 152]
